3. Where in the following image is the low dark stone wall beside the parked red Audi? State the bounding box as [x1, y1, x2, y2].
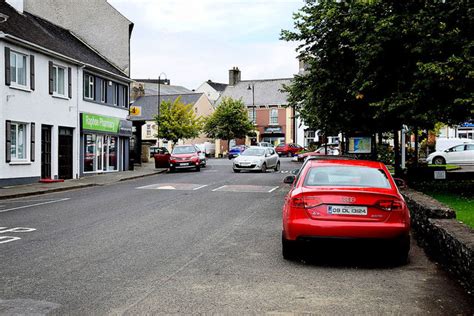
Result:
[402, 190, 474, 295]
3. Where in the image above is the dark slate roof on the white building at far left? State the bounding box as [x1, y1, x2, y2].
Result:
[0, 0, 128, 77]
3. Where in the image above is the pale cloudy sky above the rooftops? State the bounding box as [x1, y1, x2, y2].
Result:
[108, 0, 303, 89]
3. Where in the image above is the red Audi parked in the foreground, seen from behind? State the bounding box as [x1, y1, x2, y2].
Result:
[282, 158, 410, 263]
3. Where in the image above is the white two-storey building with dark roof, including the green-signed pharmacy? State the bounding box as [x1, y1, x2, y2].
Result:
[0, 1, 131, 185]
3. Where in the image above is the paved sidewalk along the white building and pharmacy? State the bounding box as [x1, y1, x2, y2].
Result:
[0, 163, 167, 200]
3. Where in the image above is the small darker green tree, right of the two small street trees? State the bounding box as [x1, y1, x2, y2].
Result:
[204, 97, 254, 148]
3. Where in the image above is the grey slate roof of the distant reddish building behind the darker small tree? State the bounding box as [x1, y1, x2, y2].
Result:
[216, 78, 292, 106]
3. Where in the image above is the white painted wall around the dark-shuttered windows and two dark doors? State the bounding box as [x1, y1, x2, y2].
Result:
[0, 41, 79, 180]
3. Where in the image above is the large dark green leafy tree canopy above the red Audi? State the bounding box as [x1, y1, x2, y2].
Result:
[282, 0, 474, 133]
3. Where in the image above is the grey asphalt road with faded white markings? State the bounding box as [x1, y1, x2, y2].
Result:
[0, 159, 474, 315]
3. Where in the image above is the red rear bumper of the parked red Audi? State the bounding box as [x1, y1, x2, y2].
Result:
[284, 219, 410, 240]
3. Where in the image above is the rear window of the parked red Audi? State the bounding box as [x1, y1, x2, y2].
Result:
[304, 166, 391, 189]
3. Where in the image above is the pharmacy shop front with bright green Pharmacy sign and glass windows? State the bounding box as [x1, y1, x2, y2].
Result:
[81, 113, 132, 175]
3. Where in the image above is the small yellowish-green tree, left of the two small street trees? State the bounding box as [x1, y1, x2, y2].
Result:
[155, 97, 202, 146]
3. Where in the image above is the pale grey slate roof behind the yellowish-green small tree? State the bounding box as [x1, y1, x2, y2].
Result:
[130, 93, 204, 121]
